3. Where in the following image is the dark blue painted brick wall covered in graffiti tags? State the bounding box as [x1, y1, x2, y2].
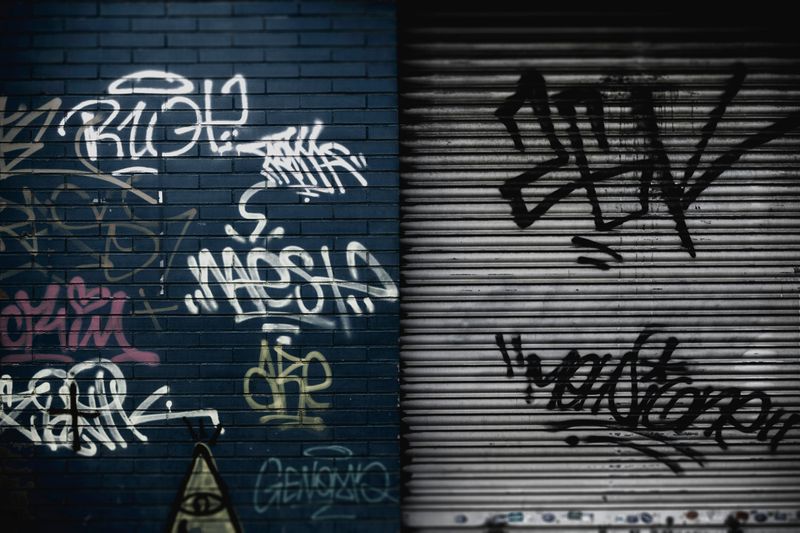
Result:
[0, 0, 400, 532]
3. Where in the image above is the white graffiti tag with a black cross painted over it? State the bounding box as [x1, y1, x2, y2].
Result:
[0, 359, 219, 457]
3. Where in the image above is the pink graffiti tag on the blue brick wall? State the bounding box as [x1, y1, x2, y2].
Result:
[0, 276, 159, 364]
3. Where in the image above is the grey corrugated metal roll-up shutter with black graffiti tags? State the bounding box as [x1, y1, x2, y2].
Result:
[400, 6, 800, 531]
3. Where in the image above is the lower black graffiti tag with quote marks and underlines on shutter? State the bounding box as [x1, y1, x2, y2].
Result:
[495, 327, 800, 473]
